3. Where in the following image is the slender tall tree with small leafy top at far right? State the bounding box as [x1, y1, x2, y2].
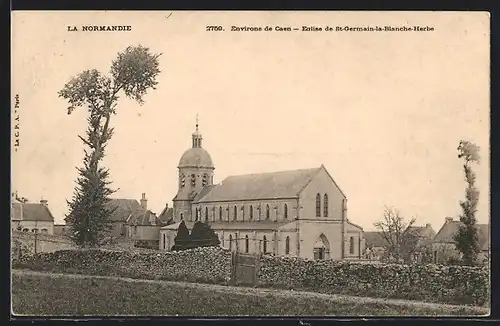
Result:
[454, 140, 480, 265]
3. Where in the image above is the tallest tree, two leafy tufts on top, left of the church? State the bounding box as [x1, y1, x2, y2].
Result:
[58, 45, 160, 247]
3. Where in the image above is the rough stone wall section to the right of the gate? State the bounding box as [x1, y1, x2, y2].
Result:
[258, 256, 490, 306]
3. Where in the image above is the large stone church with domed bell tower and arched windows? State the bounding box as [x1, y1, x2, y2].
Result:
[160, 123, 364, 260]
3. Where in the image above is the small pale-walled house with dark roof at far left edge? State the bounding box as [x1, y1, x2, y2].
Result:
[10, 198, 54, 234]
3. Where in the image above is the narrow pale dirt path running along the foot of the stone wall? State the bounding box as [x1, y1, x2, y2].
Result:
[12, 270, 490, 314]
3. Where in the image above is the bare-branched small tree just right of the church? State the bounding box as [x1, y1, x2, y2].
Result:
[374, 207, 421, 262]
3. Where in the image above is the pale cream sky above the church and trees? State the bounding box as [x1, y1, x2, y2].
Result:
[12, 12, 490, 231]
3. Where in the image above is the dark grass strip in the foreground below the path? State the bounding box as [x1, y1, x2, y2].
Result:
[12, 271, 488, 316]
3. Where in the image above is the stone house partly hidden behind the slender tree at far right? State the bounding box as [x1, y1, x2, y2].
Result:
[432, 217, 490, 263]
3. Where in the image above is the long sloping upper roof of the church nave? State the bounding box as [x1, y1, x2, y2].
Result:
[191, 167, 322, 203]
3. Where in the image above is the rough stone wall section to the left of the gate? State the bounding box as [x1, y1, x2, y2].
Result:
[13, 247, 231, 284]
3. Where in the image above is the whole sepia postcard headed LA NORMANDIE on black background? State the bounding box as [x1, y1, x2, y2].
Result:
[11, 11, 491, 317]
